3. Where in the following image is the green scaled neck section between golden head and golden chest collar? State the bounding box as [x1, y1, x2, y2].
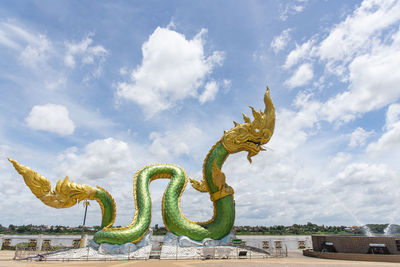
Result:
[203, 141, 229, 193]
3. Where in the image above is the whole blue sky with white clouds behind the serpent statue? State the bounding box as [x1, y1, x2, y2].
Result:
[0, 0, 400, 230]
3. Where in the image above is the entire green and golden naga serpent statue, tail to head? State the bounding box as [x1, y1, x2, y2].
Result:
[9, 87, 275, 244]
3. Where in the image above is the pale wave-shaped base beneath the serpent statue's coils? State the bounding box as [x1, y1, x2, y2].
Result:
[22, 231, 268, 261]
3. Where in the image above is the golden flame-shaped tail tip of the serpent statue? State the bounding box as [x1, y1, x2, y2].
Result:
[8, 159, 97, 209]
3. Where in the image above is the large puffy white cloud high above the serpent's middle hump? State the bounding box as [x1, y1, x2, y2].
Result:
[116, 27, 224, 118]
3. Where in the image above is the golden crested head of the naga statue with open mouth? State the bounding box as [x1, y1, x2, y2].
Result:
[222, 87, 275, 163]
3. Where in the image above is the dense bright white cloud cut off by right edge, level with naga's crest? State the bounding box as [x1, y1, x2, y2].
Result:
[323, 31, 400, 122]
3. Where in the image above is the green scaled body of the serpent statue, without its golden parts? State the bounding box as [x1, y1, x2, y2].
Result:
[94, 142, 235, 244]
